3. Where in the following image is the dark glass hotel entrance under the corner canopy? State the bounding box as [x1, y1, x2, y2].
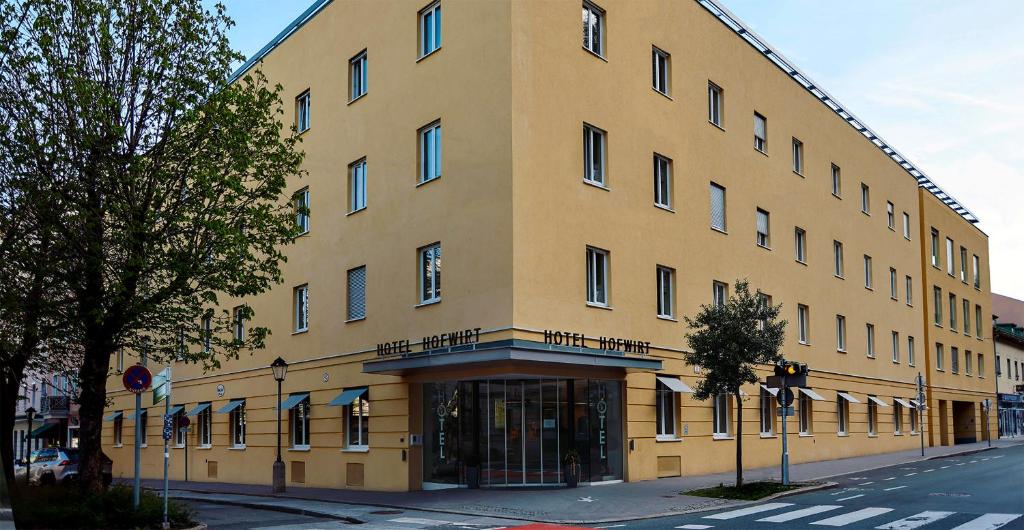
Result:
[423, 378, 623, 487]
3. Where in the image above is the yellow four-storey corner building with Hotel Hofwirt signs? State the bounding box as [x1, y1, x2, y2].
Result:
[104, 0, 994, 490]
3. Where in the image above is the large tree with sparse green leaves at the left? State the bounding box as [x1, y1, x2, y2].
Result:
[0, 0, 302, 489]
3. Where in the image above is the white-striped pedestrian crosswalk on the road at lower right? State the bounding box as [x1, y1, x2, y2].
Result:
[688, 502, 1024, 530]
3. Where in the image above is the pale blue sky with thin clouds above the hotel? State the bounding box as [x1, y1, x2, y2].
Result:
[204, 0, 1024, 300]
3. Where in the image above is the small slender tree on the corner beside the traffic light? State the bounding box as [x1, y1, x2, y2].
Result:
[683, 280, 786, 488]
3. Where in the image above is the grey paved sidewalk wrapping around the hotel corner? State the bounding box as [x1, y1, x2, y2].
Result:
[142, 440, 1024, 524]
